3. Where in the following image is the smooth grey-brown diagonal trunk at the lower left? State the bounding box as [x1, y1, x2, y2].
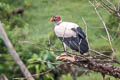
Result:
[0, 22, 34, 80]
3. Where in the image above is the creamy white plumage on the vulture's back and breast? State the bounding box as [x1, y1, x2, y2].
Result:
[54, 22, 79, 38]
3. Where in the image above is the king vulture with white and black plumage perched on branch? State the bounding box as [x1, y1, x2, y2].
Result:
[51, 16, 89, 54]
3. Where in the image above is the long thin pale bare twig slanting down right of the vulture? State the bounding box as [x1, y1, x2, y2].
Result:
[89, 0, 116, 56]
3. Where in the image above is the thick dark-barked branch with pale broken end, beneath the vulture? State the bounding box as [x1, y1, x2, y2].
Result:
[56, 54, 120, 78]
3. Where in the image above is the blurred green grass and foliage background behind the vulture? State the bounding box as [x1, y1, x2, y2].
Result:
[0, 0, 120, 80]
